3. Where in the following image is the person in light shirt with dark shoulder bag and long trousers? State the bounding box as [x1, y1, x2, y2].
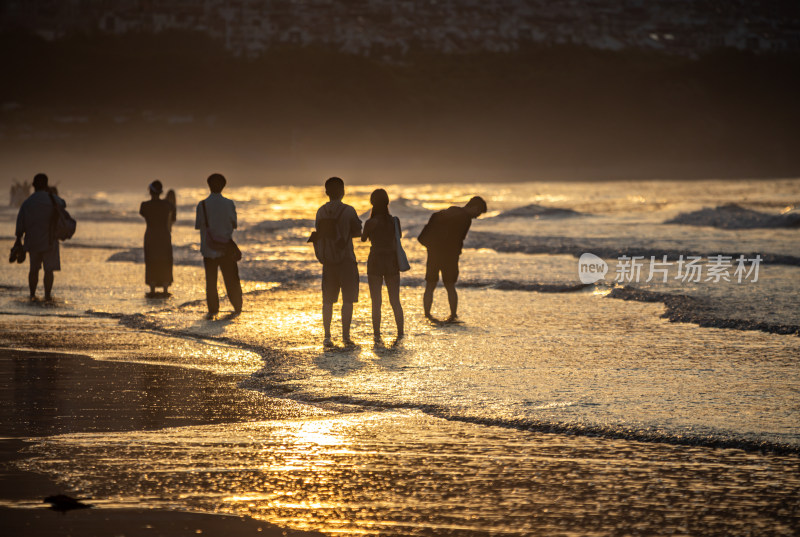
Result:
[194, 173, 242, 319]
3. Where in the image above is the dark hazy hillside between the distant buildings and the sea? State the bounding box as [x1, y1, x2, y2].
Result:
[0, 33, 800, 186]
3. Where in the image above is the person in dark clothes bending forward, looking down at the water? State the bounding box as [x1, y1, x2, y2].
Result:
[418, 196, 486, 321]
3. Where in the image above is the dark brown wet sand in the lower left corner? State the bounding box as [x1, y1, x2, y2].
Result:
[0, 349, 321, 537]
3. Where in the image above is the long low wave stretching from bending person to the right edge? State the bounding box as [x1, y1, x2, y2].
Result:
[464, 231, 800, 266]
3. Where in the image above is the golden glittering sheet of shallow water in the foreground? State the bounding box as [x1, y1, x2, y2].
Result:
[24, 411, 798, 535]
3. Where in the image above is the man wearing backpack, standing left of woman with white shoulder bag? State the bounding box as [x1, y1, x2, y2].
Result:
[313, 177, 361, 347]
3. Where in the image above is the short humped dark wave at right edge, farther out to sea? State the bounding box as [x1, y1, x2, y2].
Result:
[664, 203, 800, 229]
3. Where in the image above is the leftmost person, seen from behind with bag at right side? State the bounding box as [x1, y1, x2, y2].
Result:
[16, 173, 67, 301]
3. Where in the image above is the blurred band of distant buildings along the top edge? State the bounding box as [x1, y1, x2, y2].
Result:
[0, 0, 800, 59]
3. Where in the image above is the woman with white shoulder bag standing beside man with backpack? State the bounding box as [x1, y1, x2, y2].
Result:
[361, 188, 403, 342]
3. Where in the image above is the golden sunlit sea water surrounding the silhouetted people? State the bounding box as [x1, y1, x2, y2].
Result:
[0, 180, 800, 534]
